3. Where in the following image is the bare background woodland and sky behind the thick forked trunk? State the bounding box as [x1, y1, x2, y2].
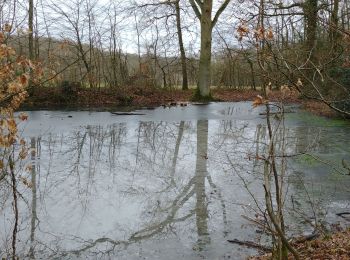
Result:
[0, 0, 350, 110]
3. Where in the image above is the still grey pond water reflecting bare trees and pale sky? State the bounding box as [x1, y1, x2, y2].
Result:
[0, 102, 350, 259]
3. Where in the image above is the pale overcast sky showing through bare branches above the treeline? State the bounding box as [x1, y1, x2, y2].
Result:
[0, 0, 306, 56]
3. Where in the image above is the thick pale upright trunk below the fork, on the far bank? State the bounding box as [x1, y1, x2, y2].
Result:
[198, 0, 213, 97]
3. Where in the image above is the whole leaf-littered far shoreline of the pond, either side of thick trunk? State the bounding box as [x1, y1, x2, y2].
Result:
[20, 87, 340, 118]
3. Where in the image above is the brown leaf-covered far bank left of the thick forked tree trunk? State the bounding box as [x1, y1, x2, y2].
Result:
[23, 87, 193, 109]
